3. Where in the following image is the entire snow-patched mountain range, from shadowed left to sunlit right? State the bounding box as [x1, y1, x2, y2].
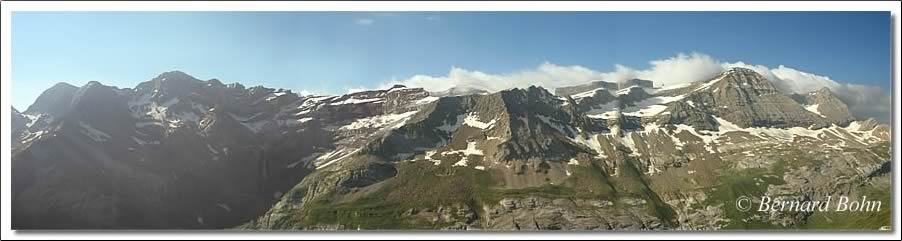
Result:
[10, 68, 892, 230]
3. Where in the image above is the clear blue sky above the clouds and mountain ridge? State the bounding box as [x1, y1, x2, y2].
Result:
[10, 12, 891, 110]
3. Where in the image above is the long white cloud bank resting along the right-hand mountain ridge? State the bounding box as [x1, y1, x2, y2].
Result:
[380, 53, 892, 121]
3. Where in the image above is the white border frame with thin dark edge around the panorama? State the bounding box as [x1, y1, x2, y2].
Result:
[0, 1, 902, 240]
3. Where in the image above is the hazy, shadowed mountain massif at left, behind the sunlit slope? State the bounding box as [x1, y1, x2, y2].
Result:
[12, 71, 438, 229]
